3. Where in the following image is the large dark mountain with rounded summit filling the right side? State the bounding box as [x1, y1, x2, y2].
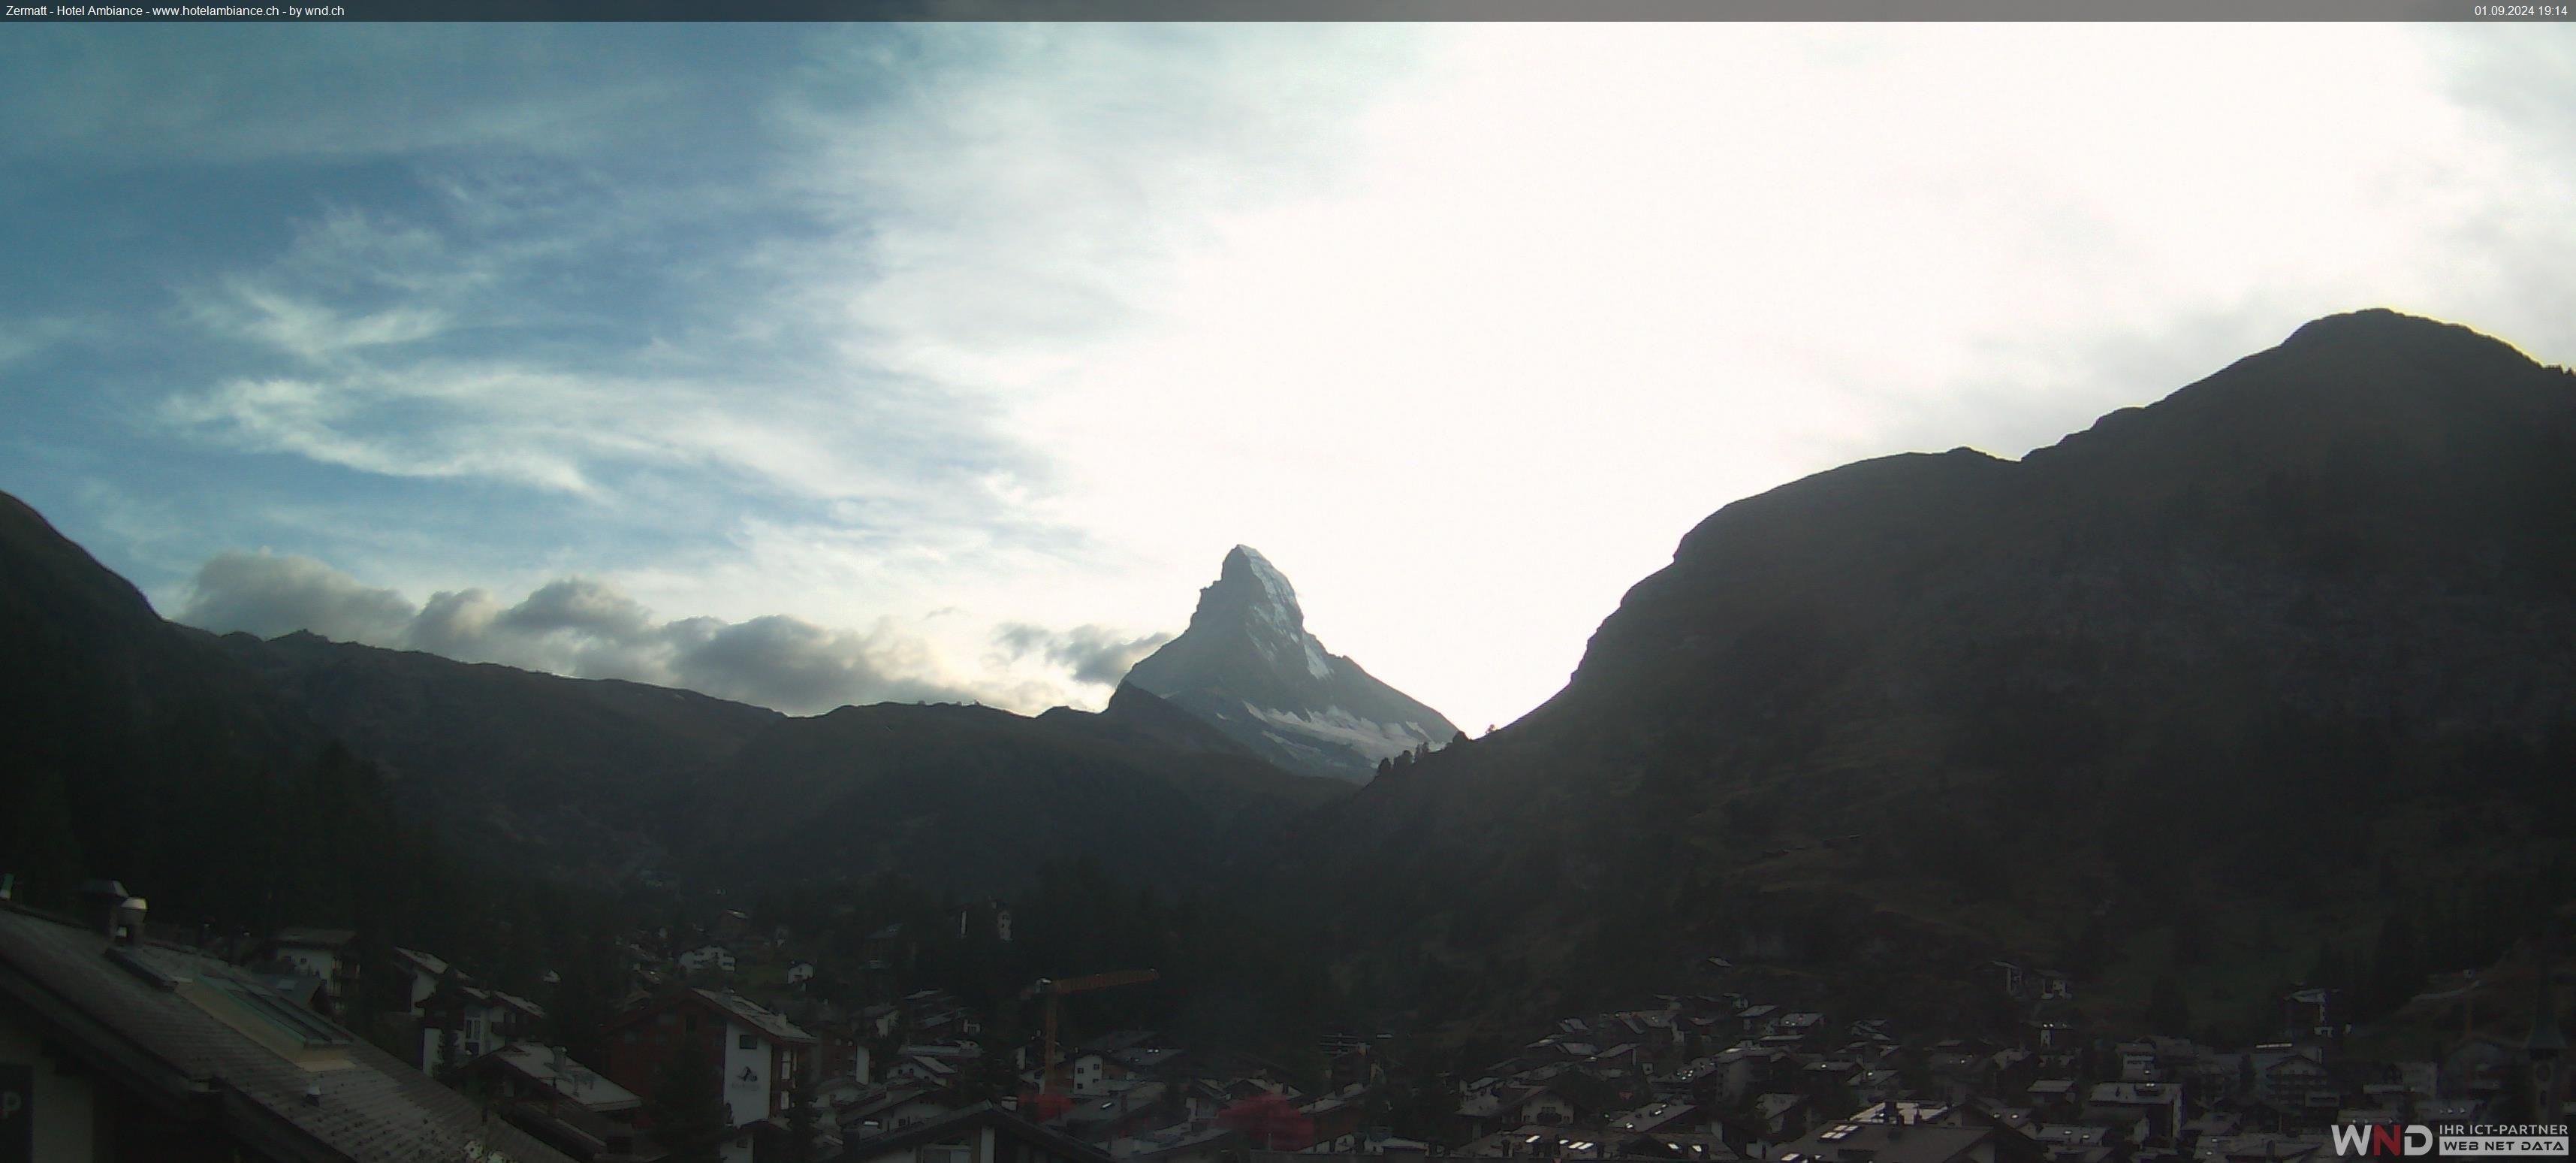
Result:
[1283, 312, 2576, 1036]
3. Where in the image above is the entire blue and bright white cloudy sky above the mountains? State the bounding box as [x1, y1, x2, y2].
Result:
[0, 23, 2576, 730]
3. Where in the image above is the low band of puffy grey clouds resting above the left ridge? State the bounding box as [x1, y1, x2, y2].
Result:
[163, 552, 1035, 714]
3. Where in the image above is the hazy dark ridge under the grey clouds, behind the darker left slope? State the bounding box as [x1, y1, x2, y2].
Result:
[224, 600, 1347, 890]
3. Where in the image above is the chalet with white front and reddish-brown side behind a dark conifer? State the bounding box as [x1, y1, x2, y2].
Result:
[608, 990, 814, 1127]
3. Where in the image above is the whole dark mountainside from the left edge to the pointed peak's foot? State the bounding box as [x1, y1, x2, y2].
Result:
[0, 495, 1350, 902]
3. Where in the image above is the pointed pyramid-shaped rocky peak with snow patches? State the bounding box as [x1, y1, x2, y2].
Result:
[1126, 544, 1458, 784]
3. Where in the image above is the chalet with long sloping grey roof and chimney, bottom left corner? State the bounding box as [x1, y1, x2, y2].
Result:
[0, 900, 567, 1163]
